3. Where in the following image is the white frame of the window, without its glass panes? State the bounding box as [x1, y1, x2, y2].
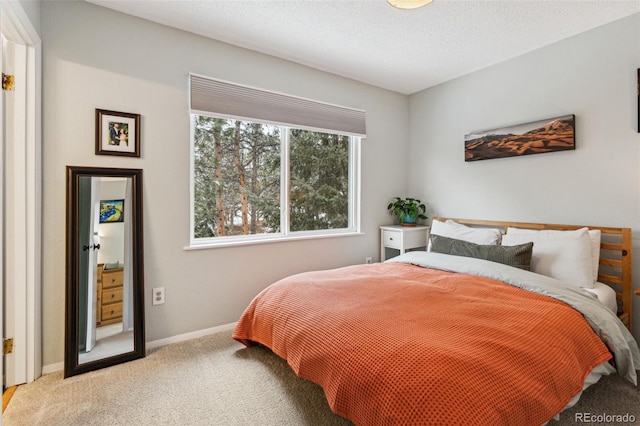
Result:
[185, 110, 362, 250]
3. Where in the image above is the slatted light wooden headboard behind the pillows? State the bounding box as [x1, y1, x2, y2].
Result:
[433, 217, 633, 330]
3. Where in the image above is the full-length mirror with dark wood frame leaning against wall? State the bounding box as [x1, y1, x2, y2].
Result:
[64, 166, 145, 377]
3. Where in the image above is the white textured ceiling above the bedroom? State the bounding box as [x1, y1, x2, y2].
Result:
[87, 0, 640, 94]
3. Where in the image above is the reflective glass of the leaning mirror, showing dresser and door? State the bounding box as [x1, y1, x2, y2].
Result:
[78, 176, 133, 364]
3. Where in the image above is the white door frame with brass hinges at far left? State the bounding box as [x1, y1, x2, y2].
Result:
[0, 0, 42, 387]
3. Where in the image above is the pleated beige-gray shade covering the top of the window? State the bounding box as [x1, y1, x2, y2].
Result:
[189, 74, 366, 137]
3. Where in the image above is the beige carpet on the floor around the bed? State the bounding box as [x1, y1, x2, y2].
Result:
[2, 331, 640, 426]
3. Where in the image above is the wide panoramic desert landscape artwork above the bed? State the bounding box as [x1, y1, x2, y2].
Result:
[464, 114, 576, 161]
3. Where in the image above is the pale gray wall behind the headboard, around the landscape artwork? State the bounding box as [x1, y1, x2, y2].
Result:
[409, 14, 640, 338]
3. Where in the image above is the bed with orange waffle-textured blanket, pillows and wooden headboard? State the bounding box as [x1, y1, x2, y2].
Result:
[233, 218, 640, 425]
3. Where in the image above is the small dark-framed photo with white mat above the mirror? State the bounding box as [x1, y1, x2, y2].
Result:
[96, 108, 140, 157]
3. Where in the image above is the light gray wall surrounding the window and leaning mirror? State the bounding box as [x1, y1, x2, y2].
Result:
[41, 1, 409, 365]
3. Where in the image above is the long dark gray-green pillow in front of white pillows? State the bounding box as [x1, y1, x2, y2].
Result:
[430, 234, 533, 271]
